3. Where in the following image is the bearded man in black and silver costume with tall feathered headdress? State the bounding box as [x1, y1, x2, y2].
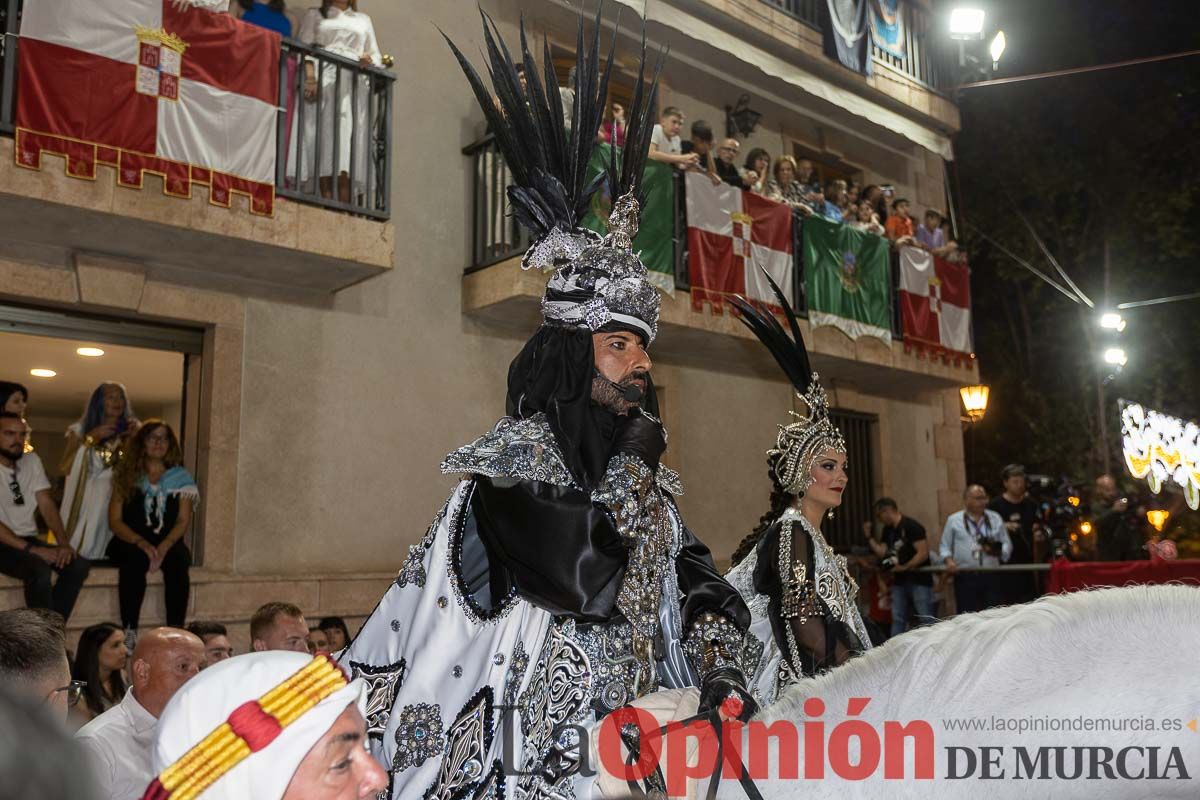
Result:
[341, 17, 754, 799]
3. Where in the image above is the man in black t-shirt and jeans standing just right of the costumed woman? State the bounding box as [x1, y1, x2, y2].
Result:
[866, 498, 937, 636]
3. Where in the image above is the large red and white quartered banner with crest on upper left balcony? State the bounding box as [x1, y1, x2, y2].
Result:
[16, 0, 280, 215]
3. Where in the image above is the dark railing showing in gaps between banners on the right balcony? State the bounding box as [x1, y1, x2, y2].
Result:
[462, 134, 902, 338]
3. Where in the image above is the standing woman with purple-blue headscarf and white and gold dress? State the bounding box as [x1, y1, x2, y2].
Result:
[59, 383, 142, 560]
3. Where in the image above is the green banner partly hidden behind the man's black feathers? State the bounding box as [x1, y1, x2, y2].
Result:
[581, 143, 674, 295]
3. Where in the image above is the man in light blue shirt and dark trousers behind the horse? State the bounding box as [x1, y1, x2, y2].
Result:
[937, 485, 1013, 614]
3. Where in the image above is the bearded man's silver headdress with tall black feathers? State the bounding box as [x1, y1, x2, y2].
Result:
[446, 10, 662, 343]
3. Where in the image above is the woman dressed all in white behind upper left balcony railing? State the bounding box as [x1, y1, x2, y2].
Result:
[289, 0, 383, 203]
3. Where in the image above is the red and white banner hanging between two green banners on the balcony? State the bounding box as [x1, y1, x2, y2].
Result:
[685, 173, 796, 313]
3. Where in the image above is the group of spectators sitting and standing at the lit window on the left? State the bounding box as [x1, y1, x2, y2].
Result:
[0, 381, 199, 646]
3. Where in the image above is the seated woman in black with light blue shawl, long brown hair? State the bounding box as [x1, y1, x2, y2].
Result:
[108, 420, 200, 638]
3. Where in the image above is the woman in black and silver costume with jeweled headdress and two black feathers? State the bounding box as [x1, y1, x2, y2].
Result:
[726, 276, 871, 705]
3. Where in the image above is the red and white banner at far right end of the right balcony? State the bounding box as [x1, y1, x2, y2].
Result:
[900, 247, 974, 365]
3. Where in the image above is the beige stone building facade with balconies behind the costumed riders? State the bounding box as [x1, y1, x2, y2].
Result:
[0, 0, 978, 645]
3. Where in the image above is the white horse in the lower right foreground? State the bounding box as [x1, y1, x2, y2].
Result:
[585, 585, 1200, 800]
